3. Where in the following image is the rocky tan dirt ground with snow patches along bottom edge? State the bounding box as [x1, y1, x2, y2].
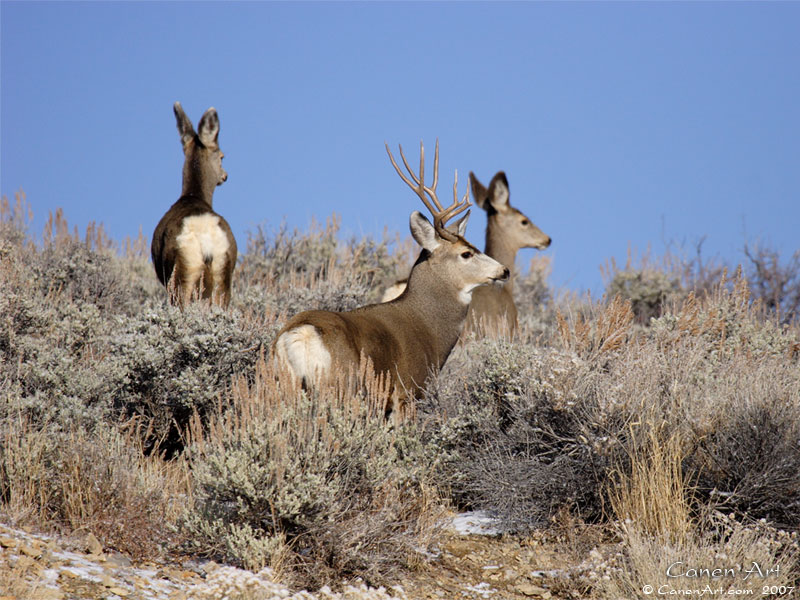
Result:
[0, 525, 600, 600]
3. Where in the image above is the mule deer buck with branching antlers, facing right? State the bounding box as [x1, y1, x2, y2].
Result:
[273, 140, 509, 413]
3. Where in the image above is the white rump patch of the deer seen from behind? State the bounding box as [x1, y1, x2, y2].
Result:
[175, 213, 230, 280]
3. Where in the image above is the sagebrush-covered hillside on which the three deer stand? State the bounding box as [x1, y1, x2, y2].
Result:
[0, 195, 800, 600]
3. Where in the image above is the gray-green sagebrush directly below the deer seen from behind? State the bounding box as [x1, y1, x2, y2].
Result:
[108, 302, 276, 455]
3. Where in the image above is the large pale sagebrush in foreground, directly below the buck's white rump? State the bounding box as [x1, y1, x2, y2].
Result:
[186, 363, 441, 587]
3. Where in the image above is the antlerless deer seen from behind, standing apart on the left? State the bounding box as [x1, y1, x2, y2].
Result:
[150, 102, 237, 308]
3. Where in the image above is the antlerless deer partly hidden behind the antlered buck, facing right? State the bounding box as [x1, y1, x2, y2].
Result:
[383, 171, 551, 335]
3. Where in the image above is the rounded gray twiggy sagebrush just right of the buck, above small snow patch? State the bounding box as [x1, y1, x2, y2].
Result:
[422, 341, 605, 529]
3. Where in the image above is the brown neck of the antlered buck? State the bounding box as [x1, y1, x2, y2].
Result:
[402, 261, 469, 367]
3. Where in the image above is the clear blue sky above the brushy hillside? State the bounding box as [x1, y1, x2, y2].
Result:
[0, 0, 800, 291]
